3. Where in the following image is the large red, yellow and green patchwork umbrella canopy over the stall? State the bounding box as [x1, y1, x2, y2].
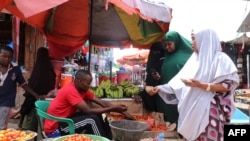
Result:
[0, 0, 171, 58]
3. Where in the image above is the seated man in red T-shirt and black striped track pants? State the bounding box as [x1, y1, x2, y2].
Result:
[44, 70, 133, 139]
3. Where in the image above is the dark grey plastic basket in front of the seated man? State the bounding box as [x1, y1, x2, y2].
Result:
[109, 120, 149, 141]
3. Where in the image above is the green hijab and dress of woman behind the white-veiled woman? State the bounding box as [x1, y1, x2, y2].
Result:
[157, 31, 193, 123]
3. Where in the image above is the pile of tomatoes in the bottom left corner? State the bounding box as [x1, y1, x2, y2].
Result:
[0, 128, 36, 141]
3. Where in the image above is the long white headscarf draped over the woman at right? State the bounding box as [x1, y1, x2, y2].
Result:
[158, 29, 239, 141]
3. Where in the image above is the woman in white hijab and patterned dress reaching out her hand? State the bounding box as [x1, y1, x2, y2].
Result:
[146, 29, 239, 141]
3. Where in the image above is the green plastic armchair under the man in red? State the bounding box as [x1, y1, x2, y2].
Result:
[35, 100, 75, 138]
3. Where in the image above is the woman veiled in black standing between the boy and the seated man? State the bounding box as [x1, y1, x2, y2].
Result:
[19, 47, 56, 132]
